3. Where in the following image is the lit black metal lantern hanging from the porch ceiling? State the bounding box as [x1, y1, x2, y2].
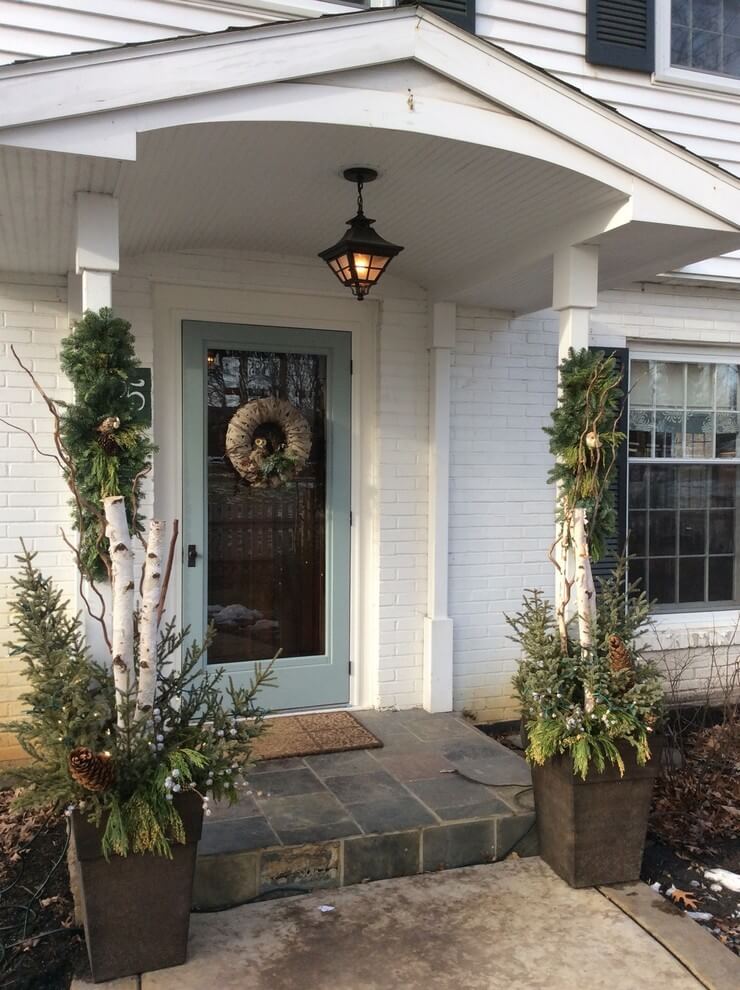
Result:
[319, 168, 403, 299]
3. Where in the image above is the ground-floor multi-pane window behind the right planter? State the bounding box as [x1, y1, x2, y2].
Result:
[627, 356, 740, 611]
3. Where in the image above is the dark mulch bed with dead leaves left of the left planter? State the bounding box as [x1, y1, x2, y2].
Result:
[0, 790, 87, 990]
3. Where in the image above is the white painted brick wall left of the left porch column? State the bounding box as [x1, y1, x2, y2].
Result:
[0, 274, 74, 763]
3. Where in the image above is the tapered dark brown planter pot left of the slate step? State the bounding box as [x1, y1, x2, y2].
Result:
[72, 794, 203, 983]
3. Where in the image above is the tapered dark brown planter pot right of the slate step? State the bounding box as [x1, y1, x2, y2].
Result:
[532, 737, 663, 887]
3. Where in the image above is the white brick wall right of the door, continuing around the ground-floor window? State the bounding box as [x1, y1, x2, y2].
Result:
[450, 285, 740, 719]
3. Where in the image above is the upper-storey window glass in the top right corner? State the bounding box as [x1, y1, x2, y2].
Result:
[671, 0, 740, 79]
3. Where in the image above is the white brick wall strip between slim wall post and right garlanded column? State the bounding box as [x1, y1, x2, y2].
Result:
[450, 310, 557, 719]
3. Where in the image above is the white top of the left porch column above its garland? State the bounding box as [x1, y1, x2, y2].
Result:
[70, 192, 119, 314]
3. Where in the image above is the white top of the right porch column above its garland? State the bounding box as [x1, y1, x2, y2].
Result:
[552, 244, 599, 356]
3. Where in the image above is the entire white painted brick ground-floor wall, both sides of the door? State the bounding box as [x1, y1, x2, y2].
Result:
[0, 260, 740, 760]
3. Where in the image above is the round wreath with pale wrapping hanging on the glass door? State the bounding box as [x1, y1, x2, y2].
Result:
[226, 396, 311, 488]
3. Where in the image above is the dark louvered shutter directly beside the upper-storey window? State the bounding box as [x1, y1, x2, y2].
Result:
[586, 0, 655, 72]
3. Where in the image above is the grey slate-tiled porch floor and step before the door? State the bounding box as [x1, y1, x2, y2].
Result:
[195, 710, 535, 908]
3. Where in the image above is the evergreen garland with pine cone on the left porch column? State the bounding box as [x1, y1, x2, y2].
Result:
[60, 309, 154, 579]
